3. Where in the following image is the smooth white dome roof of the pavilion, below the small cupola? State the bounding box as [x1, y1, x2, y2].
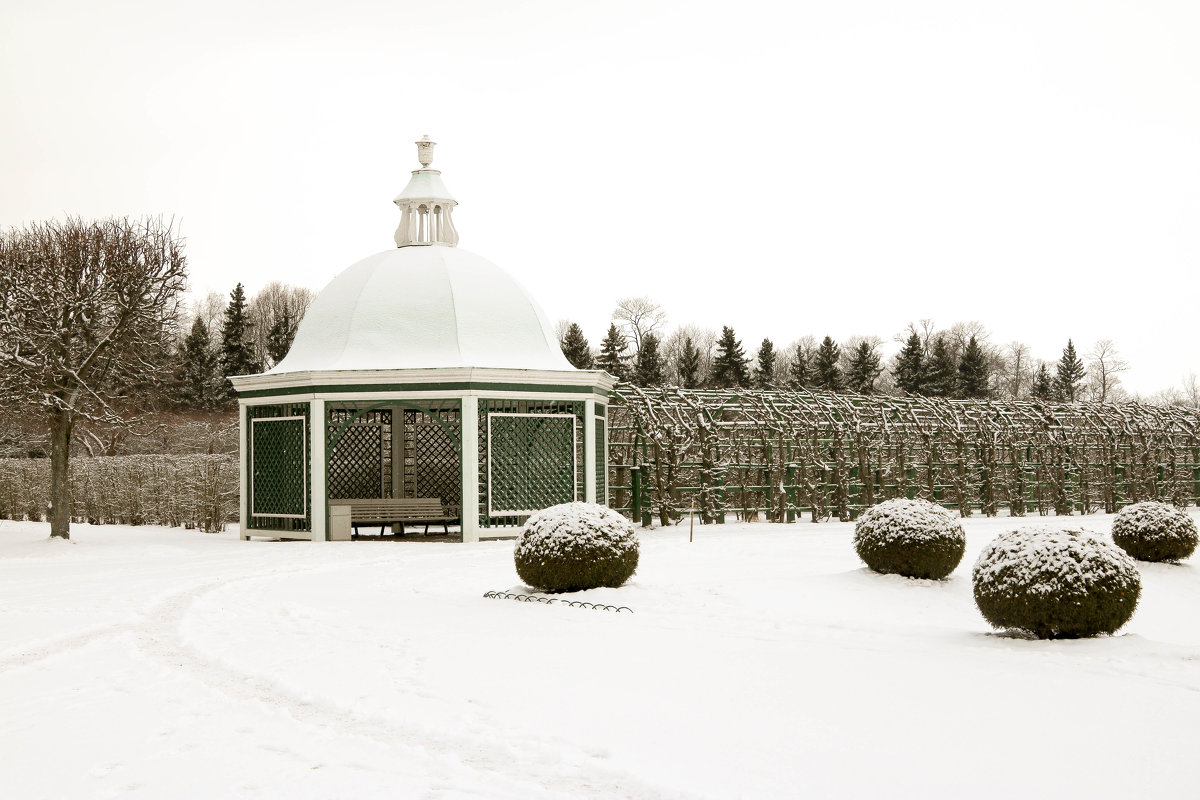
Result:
[266, 245, 575, 374]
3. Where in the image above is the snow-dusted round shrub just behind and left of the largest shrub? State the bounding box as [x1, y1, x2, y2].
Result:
[854, 498, 967, 579]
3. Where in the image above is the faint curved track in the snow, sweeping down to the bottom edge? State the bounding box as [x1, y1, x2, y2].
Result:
[130, 568, 685, 800]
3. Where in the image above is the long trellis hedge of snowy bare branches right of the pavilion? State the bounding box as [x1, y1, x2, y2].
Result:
[608, 385, 1200, 524]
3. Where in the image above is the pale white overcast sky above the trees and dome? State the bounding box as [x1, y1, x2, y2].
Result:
[0, 0, 1200, 392]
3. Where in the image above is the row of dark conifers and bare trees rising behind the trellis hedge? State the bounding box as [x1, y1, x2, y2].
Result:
[558, 297, 1152, 402]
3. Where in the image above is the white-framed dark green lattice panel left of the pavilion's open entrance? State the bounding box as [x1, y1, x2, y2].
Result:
[251, 416, 307, 518]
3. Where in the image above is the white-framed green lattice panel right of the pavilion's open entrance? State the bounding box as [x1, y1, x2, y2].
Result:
[488, 414, 577, 515]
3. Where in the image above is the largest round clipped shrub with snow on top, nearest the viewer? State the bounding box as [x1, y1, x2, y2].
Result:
[971, 528, 1141, 639]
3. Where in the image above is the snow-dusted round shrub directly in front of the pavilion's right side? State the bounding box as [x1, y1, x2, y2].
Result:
[512, 503, 637, 593]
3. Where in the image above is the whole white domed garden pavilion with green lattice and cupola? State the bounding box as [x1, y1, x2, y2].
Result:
[232, 137, 613, 541]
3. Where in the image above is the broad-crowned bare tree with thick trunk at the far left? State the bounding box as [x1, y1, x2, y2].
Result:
[0, 218, 187, 539]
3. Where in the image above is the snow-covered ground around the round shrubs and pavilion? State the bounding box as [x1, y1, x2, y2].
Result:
[0, 510, 1200, 800]
